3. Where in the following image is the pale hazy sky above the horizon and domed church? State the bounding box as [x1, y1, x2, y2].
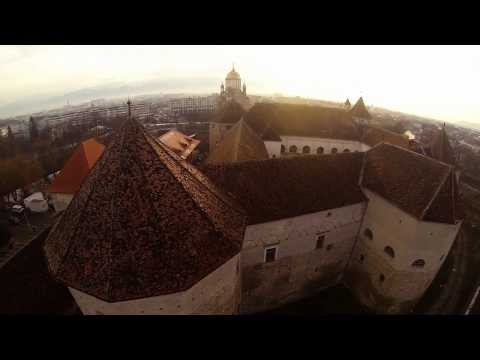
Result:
[0, 45, 480, 122]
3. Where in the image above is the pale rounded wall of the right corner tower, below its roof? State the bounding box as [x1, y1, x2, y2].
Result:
[347, 189, 461, 313]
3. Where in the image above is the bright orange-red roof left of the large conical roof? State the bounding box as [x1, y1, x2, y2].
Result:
[47, 139, 105, 194]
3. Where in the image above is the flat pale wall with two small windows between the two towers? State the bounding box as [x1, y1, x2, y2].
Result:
[241, 203, 364, 313]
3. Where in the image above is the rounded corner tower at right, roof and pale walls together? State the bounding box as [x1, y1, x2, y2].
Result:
[346, 143, 462, 313]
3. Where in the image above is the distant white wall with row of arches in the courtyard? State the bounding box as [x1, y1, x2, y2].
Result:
[281, 136, 365, 154]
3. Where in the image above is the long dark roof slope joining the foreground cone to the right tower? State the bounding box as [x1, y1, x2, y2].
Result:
[202, 153, 366, 224]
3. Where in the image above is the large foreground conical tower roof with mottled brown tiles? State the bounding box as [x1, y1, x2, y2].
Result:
[44, 115, 245, 302]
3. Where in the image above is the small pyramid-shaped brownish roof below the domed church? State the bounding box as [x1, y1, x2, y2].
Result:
[207, 119, 268, 163]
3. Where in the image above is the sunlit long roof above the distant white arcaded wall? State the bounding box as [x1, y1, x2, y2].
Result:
[245, 103, 360, 140]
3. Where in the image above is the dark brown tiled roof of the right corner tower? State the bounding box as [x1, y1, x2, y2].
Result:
[362, 144, 456, 223]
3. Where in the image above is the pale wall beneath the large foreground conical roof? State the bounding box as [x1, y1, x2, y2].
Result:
[69, 254, 240, 315]
